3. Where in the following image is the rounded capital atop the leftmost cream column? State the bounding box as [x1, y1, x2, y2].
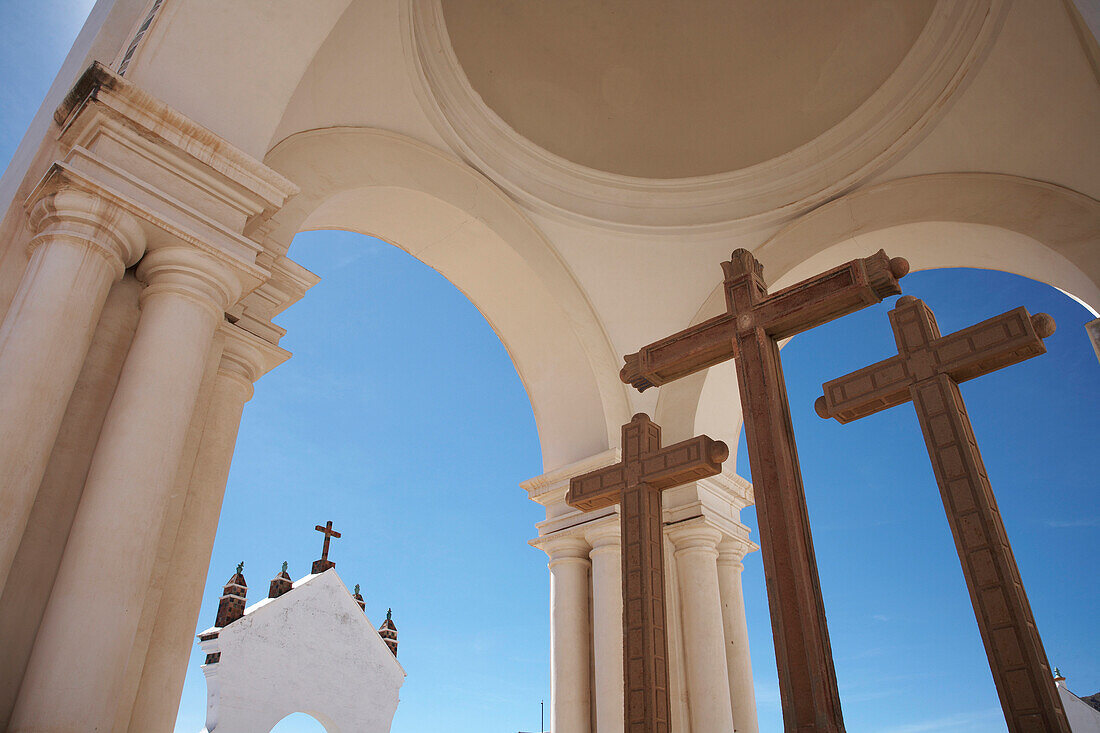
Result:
[28, 188, 145, 280]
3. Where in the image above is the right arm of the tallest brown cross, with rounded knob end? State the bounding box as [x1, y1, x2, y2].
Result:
[752, 250, 909, 339]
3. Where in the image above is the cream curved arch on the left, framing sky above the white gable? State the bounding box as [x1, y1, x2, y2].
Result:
[265, 128, 629, 470]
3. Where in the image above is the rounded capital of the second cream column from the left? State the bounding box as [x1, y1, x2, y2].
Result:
[138, 247, 242, 319]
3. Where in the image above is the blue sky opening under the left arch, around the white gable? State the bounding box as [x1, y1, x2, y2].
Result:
[180, 231, 549, 733]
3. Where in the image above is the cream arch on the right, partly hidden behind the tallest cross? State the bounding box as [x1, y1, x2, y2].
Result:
[657, 173, 1100, 460]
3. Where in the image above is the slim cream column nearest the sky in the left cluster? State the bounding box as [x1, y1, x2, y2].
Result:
[130, 324, 277, 733]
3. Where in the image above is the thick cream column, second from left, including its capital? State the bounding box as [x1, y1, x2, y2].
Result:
[10, 247, 241, 733]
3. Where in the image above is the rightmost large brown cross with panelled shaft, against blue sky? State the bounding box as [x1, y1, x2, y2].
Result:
[814, 296, 1069, 733]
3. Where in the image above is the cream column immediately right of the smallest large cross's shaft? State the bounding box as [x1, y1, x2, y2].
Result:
[669, 522, 734, 733]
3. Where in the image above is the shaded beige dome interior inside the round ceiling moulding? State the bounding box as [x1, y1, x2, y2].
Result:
[442, 0, 935, 178]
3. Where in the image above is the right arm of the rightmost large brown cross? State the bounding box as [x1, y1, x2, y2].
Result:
[933, 307, 1055, 383]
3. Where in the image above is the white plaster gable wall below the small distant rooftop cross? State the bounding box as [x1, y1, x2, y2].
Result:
[204, 570, 405, 733]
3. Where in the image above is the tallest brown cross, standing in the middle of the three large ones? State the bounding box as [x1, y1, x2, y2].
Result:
[619, 250, 909, 733]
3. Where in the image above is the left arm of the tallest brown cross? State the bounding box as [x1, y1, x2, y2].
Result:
[619, 314, 734, 392]
